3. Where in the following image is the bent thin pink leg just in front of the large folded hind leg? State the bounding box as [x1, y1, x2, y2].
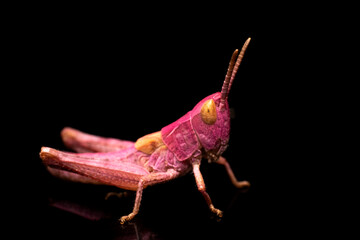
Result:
[119, 169, 180, 224]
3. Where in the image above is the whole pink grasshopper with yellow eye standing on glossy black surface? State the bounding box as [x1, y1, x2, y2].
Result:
[40, 38, 250, 224]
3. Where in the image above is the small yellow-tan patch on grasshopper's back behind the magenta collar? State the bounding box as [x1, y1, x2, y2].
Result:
[135, 131, 164, 154]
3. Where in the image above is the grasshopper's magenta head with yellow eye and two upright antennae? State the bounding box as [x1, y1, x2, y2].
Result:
[191, 38, 250, 161]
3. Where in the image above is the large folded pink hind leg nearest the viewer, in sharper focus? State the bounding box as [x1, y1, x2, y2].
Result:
[40, 147, 149, 191]
